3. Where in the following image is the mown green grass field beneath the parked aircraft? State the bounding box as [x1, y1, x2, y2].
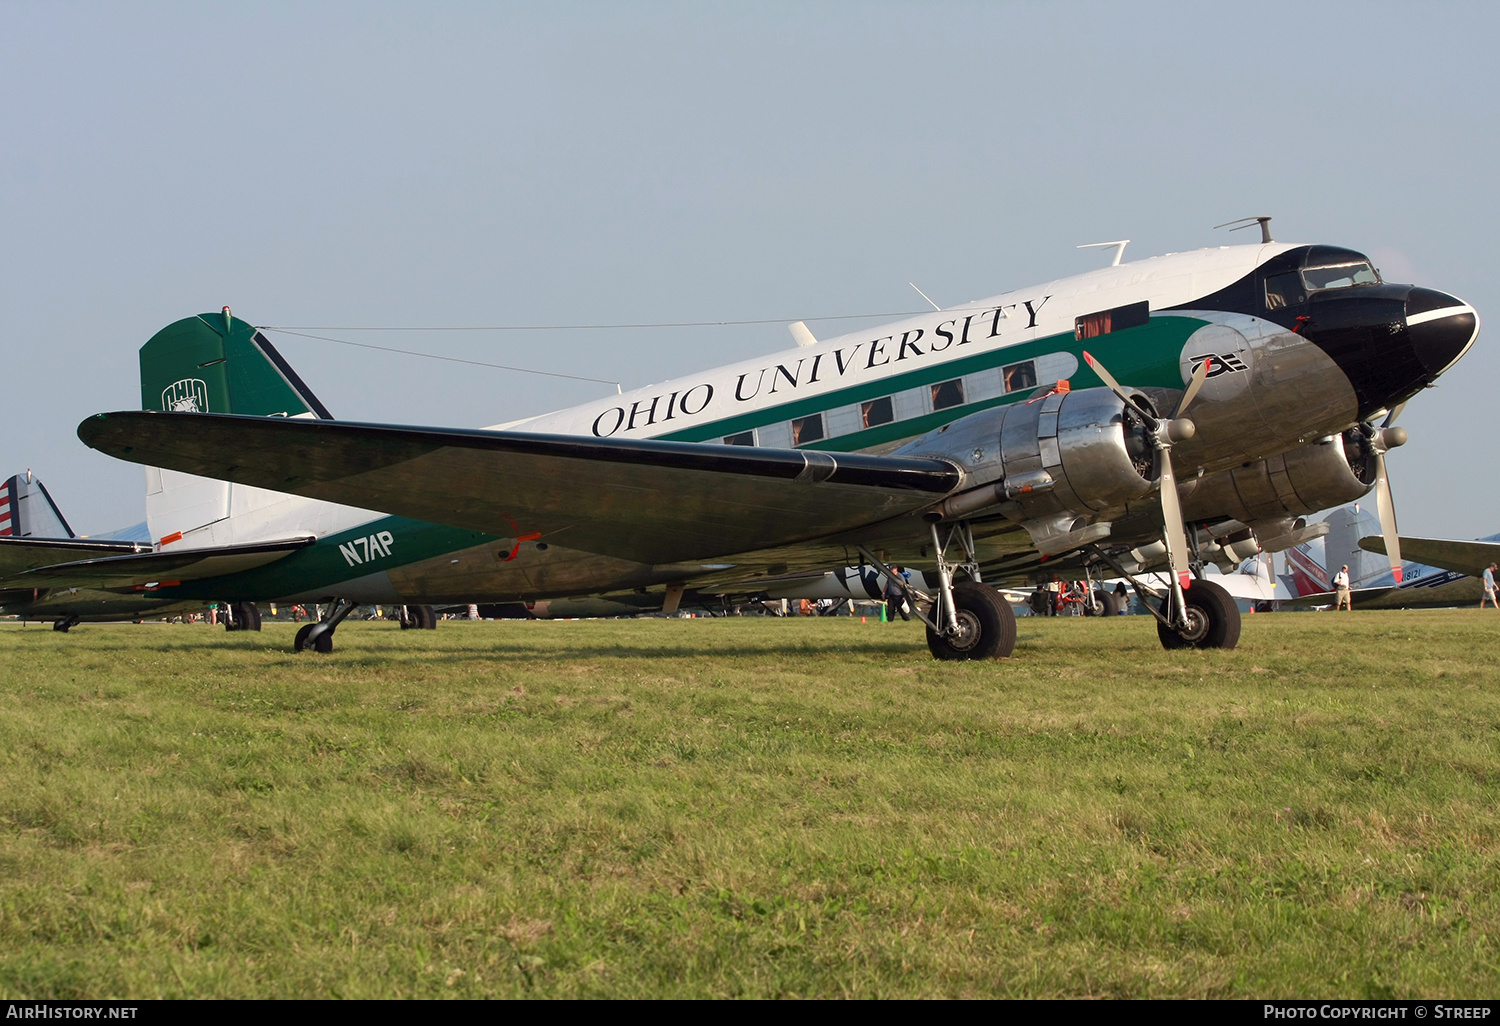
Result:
[0, 611, 1500, 998]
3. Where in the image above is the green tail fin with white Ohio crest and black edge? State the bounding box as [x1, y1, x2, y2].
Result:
[141, 306, 333, 420]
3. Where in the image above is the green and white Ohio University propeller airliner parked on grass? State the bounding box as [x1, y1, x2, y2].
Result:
[17, 221, 1479, 660]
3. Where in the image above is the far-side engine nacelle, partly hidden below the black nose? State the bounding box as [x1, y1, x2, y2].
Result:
[1182, 429, 1376, 524]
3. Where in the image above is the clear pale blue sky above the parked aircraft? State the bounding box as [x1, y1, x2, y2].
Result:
[0, 3, 1500, 537]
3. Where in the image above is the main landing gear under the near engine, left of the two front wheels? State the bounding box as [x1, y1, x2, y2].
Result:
[860, 521, 1016, 662]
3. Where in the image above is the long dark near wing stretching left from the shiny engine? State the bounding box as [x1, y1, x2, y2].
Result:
[78, 411, 962, 564]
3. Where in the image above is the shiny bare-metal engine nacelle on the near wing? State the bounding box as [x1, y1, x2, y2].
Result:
[897, 389, 1154, 521]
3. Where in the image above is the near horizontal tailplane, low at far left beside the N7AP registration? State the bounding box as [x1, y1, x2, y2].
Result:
[0, 537, 314, 591]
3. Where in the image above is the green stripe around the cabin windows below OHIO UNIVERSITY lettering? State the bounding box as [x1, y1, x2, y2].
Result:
[659, 315, 1206, 452]
